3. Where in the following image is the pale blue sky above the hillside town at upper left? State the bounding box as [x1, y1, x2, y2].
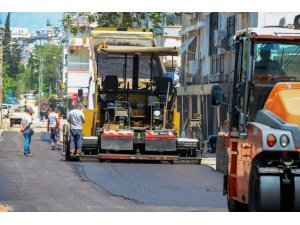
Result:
[0, 12, 63, 32]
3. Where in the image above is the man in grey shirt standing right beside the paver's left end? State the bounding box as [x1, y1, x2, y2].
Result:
[68, 103, 85, 155]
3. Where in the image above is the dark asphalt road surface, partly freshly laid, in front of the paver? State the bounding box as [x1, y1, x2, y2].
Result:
[0, 127, 227, 212]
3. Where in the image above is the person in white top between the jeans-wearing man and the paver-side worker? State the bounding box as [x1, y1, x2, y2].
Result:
[47, 108, 60, 151]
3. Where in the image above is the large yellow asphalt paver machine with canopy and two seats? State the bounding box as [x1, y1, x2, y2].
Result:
[64, 29, 201, 162]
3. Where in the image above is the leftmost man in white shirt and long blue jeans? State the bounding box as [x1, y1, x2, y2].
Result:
[20, 106, 33, 156]
